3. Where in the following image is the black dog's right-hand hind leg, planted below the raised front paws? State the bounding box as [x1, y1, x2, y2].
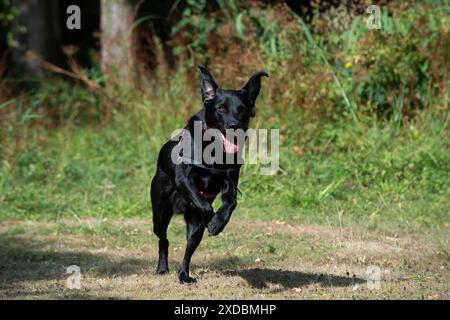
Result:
[178, 212, 205, 283]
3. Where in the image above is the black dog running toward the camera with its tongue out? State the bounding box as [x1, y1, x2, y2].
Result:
[151, 67, 269, 282]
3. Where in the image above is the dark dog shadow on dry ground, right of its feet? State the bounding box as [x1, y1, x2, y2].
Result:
[223, 268, 365, 291]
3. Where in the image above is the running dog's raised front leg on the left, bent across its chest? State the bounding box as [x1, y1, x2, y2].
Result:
[175, 169, 214, 227]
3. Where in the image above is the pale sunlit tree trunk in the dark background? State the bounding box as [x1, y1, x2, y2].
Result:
[100, 0, 136, 85]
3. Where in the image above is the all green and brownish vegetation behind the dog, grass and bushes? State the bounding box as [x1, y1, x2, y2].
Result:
[0, 1, 450, 230]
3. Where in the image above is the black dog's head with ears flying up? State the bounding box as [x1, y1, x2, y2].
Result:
[199, 67, 269, 134]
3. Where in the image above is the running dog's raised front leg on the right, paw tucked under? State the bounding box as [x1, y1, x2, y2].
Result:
[208, 180, 237, 236]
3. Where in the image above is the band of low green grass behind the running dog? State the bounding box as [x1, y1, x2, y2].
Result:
[0, 105, 450, 232]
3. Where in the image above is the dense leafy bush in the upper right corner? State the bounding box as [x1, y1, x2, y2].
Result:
[347, 6, 450, 121]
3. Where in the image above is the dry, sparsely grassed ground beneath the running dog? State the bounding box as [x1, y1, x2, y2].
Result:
[0, 217, 450, 299]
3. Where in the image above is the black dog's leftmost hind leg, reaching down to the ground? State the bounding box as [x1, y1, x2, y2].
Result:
[151, 175, 173, 274]
